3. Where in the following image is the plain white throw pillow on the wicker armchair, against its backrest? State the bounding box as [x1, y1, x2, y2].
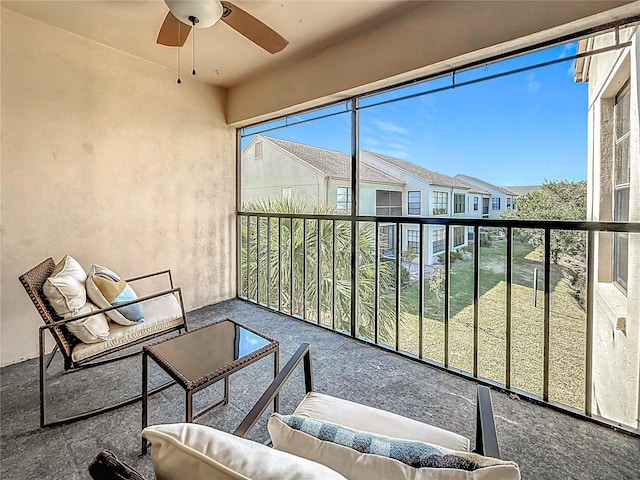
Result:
[42, 255, 87, 318]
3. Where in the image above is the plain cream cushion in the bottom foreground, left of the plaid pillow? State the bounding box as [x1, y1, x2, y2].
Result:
[142, 423, 346, 480]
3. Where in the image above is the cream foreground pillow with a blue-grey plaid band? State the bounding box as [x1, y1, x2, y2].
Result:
[268, 414, 520, 480]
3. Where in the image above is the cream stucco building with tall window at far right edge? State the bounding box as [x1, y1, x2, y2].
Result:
[575, 27, 640, 428]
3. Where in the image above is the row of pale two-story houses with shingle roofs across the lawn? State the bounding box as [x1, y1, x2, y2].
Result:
[241, 135, 490, 264]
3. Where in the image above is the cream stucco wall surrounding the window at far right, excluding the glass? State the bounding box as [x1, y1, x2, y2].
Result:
[588, 30, 640, 427]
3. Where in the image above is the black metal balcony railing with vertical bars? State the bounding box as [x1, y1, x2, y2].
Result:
[237, 212, 640, 434]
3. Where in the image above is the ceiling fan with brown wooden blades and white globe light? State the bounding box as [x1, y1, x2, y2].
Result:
[157, 0, 289, 53]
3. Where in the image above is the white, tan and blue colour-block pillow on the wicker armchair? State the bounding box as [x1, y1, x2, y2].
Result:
[87, 265, 144, 325]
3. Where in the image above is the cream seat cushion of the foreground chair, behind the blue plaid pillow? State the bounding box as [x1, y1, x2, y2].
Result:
[294, 392, 470, 452]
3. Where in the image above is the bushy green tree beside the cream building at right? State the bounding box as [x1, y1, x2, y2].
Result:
[503, 180, 587, 263]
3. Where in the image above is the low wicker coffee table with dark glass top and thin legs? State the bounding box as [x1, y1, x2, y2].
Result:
[142, 319, 280, 454]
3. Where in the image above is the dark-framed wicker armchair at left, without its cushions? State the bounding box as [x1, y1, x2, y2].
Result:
[19, 258, 188, 427]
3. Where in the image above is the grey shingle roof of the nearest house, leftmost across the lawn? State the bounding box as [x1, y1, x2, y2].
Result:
[263, 136, 404, 185]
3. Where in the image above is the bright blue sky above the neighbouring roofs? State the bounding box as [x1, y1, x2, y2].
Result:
[246, 43, 587, 185]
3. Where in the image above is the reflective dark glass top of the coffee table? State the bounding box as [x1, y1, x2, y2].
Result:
[146, 320, 277, 382]
